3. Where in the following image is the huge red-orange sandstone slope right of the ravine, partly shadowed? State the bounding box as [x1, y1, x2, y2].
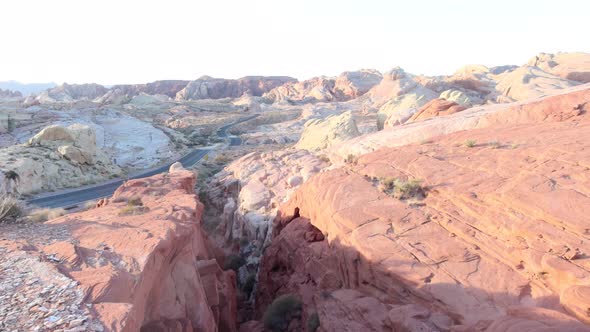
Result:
[256, 85, 590, 331]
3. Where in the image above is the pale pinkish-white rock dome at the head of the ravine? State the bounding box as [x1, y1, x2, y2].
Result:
[207, 149, 328, 255]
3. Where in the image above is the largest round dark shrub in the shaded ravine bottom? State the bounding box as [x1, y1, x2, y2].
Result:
[262, 294, 301, 331]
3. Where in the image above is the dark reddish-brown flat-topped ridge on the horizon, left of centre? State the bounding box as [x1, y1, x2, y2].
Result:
[176, 76, 296, 101]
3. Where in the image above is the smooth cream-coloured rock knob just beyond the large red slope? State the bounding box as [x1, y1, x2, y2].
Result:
[295, 112, 360, 151]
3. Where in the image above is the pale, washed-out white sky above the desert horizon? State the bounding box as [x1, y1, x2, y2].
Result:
[0, 0, 590, 84]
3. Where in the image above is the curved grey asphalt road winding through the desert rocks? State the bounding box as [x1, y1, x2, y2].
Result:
[27, 115, 258, 209]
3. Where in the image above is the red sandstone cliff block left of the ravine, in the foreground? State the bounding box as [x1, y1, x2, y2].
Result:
[0, 168, 237, 332]
